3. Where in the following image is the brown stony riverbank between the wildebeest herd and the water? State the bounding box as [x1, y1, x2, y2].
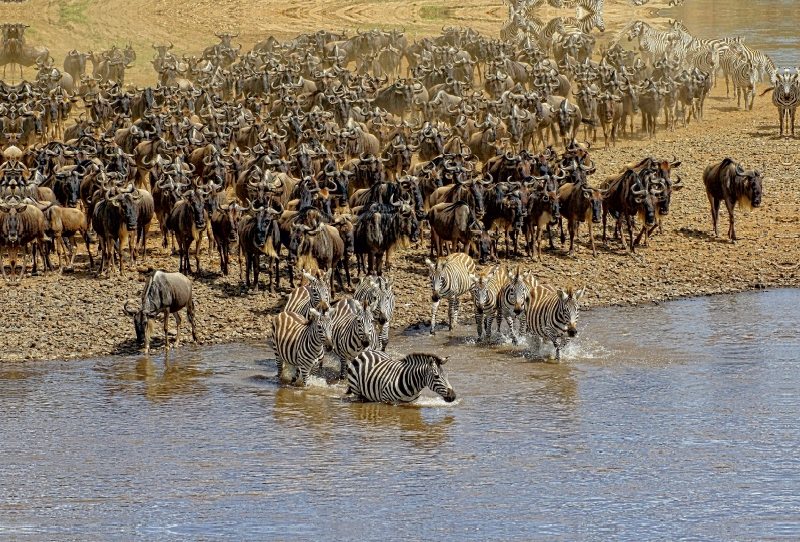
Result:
[0, 82, 800, 361]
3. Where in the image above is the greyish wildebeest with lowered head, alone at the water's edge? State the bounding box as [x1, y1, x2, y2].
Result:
[122, 270, 202, 356]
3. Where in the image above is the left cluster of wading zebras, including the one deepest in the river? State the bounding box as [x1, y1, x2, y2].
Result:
[273, 270, 456, 403]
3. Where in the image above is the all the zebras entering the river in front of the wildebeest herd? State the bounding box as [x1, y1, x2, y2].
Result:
[272, 252, 584, 403]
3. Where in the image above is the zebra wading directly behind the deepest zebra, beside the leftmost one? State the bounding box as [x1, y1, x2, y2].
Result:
[331, 299, 378, 379]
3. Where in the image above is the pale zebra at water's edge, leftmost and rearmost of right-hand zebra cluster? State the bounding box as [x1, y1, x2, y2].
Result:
[425, 252, 475, 335]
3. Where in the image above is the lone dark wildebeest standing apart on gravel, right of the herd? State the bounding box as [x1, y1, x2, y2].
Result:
[703, 158, 766, 241]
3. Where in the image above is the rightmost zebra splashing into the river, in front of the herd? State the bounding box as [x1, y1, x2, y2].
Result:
[525, 284, 585, 360]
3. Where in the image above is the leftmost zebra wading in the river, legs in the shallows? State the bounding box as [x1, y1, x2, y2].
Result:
[272, 302, 335, 386]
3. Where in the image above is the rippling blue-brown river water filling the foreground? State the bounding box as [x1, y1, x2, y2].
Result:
[0, 290, 800, 540]
